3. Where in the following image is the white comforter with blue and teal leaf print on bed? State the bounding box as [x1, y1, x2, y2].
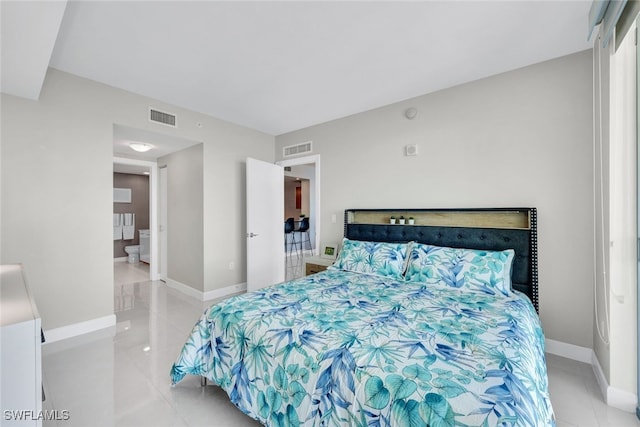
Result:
[171, 270, 555, 427]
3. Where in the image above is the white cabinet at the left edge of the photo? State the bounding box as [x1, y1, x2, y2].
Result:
[0, 264, 42, 427]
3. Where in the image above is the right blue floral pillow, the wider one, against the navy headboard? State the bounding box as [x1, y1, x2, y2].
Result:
[405, 243, 515, 295]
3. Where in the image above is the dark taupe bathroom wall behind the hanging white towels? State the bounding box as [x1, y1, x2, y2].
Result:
[113, 173, 149, 258]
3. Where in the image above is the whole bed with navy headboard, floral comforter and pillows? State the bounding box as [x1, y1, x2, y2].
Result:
[170, 208, 555, 427]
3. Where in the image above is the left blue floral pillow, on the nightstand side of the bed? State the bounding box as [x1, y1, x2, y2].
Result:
[333, 237, 409, 280]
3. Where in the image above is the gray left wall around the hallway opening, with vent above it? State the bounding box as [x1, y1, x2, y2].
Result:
[0, 69, 275, 330]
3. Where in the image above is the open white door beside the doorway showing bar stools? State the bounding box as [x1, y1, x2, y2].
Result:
[247, 158, 285, 292]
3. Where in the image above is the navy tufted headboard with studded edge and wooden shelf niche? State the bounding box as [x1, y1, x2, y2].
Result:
[344, 208, 538, 311]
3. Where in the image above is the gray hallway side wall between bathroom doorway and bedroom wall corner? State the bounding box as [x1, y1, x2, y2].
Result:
[158, 144, 204, 291]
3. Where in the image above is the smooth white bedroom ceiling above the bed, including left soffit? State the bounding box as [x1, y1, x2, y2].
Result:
[2, 0, 591, 135]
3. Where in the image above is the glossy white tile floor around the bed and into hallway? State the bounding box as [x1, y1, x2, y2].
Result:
[43, 262, 640, 427]
